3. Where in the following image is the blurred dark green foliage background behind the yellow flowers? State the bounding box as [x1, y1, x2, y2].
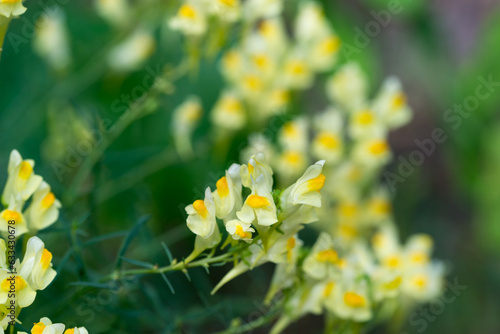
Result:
[0, 0, 500, 334]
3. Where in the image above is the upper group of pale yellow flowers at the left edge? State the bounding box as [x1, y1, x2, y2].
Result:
[0, 150, 61, 237]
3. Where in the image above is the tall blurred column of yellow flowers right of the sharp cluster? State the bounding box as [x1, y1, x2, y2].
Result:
[235, 63, 444, 333]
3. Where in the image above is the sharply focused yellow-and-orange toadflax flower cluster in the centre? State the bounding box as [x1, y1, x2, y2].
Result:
[186, 154, 325, 292]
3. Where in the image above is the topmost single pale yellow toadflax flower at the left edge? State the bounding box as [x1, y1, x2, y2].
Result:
[2, 150, 42, 205]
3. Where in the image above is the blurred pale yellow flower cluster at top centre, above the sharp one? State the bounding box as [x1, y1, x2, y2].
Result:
[211, 2, 341, 131]
